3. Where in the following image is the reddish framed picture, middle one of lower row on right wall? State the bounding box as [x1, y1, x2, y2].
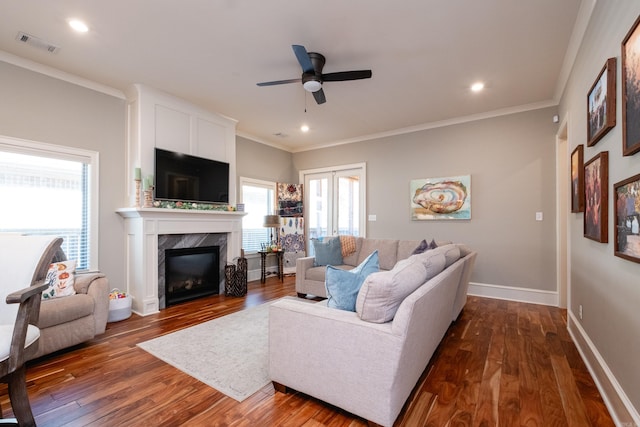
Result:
[584, 151, 609, 243]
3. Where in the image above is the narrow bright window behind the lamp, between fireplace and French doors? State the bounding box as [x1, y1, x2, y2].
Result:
[240, 177, 276, 252]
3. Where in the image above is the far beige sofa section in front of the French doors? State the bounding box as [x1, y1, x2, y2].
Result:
[296, 237, 444, 298]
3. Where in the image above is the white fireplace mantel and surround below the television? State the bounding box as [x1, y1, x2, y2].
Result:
[117, 208, 245, 316]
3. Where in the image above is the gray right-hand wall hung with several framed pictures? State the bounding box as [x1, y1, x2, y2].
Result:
[560, 0, 640, 414]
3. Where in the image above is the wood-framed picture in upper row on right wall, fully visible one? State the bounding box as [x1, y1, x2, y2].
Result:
[587, 58, 616, 147]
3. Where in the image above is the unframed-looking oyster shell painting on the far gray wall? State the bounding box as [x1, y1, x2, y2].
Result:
[409, 175, 471, 221]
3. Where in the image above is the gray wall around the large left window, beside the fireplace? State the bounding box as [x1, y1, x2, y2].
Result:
[0, 61, 126, 288]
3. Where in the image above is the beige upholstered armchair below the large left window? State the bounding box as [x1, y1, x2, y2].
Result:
[31, 273, 109, 359]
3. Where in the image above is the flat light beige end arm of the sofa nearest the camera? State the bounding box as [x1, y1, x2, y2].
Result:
[269, 299, 404, 425]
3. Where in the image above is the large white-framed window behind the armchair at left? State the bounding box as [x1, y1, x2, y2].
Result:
[0, 137, 98, 270]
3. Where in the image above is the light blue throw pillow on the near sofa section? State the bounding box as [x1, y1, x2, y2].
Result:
[324, 250, 380, 311]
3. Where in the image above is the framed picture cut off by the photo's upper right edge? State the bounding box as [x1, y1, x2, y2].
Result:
[622, 17, 640, 156]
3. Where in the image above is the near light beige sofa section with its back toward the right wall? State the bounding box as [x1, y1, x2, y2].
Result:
[269, 245, 476, 426]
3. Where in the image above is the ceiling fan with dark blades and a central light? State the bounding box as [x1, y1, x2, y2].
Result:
[258, 44, 371, 104]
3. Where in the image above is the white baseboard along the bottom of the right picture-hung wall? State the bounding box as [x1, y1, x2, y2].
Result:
[567, 311, 640, 427]
